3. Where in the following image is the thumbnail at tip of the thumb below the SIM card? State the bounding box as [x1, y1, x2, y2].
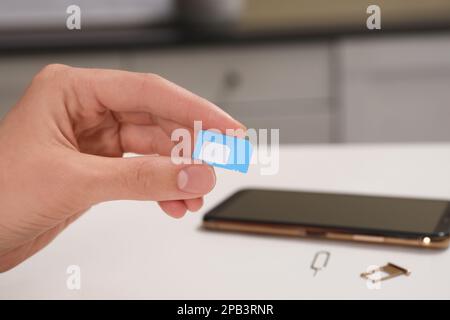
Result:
[177, 165, 216, 194]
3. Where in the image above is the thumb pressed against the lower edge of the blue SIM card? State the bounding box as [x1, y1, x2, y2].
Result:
[79, 156, 216, 203]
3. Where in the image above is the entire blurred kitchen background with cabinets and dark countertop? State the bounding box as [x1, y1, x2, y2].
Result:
[0, 0, 450, 143]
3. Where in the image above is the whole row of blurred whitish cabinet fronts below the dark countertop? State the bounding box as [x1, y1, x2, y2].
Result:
[0, 33, 450, 143]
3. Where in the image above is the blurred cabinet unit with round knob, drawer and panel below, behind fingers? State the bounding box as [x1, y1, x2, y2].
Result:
[124, 43, 331, 143]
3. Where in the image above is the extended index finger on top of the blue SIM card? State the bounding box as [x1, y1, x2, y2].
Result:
[72, 69, 245, 132]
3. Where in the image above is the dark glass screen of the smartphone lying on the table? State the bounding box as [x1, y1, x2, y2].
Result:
[205, 190, 450, 234]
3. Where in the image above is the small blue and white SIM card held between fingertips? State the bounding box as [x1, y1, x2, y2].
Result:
[192, 130, 253, 173]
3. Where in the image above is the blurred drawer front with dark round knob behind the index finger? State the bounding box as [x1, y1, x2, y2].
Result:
[127, 44, 329, 101]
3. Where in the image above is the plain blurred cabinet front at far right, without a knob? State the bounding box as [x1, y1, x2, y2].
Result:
[337, 34, 450, 142]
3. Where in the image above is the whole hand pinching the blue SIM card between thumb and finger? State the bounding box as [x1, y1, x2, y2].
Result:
[0, 65, 244, 271]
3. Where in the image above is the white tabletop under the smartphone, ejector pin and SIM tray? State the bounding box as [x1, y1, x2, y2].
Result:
[0, 144, 450, 299]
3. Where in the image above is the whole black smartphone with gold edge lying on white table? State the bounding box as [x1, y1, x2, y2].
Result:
[203, 189, 450, 248]
